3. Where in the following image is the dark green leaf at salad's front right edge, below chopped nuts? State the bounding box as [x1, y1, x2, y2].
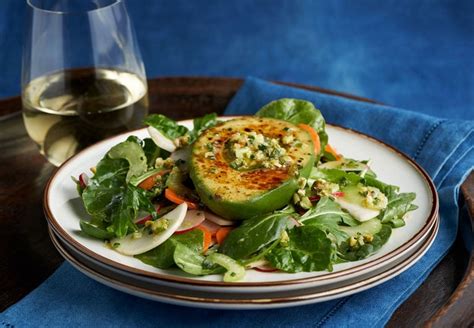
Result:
[338, 224, 392, 261]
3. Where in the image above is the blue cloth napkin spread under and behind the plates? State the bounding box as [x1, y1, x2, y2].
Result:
[0, 78, 474, 327]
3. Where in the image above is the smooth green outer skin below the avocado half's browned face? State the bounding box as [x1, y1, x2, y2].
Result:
[190, 154, 315, 220]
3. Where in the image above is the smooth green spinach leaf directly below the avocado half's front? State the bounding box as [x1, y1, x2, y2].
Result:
[219, 212, 293, 260]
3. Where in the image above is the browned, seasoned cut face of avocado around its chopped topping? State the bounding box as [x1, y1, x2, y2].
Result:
[192, 117, 312, 201]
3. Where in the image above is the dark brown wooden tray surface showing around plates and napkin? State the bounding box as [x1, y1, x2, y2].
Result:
[0, 77, 474, 327]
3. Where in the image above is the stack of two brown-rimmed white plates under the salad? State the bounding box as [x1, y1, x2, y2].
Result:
[44, 121, 439, 309]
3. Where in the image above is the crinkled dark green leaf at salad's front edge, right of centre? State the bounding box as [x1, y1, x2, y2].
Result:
[266, 225, 335, 272]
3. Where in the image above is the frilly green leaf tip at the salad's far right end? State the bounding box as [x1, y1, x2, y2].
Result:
[380, 193, 418, 228]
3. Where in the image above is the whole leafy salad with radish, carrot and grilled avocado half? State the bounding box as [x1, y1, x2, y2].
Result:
[74, 99, 417, 282]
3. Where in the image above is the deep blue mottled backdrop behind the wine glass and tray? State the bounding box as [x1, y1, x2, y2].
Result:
[0, 0, 474, 119]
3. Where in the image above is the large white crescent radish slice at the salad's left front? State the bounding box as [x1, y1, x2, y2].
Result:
[110, 203, 188, 255]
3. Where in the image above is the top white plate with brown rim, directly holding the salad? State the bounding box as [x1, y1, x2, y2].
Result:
[44, 118, 438, 292]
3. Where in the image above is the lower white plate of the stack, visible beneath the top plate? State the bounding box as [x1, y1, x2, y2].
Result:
[49, 221, 439, 310]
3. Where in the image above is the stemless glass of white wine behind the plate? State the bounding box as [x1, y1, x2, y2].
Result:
[22, 0, 148, 165]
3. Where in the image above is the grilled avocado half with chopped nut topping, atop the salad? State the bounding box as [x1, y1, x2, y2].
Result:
[190, 116, 317, 220]
